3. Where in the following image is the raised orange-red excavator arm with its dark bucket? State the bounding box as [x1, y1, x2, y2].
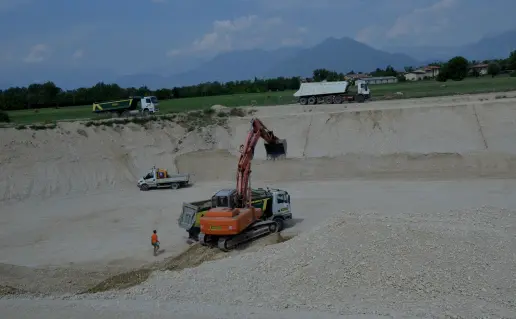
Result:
[235, 118, 287, 207]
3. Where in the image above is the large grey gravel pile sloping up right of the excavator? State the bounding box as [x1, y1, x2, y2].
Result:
[80, 207, 516, 318]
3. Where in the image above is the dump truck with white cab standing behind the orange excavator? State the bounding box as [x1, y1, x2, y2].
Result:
[178, 188, 292, 241]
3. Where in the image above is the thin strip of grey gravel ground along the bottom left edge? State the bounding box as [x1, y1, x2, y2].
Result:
[0, 300, 400, 319]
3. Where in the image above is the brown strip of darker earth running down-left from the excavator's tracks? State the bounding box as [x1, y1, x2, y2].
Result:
[83, 233, 294, 294]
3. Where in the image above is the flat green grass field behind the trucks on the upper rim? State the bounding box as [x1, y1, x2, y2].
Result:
[8, 76, 516, 124]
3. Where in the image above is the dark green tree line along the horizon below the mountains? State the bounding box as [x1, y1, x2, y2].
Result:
[0, 51, 516, 111]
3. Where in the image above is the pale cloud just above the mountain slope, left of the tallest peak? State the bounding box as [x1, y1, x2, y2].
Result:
[167, 15, 307, 56]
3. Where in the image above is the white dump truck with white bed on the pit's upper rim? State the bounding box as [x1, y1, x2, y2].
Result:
[294, 80, 371, 105]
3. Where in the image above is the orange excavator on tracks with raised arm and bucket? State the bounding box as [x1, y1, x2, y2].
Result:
[199, 118, 286, 251]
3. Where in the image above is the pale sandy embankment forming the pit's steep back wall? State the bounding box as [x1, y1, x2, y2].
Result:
[0, 99, 516, 200]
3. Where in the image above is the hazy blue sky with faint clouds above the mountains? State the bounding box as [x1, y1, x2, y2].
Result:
[0, 0, 516, 84]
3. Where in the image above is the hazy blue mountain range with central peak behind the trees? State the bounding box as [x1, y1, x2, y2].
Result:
[116, 30, 516, 88]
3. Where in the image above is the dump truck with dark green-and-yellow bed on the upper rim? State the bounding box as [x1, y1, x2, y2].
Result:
[93, 96, 159, 117]
